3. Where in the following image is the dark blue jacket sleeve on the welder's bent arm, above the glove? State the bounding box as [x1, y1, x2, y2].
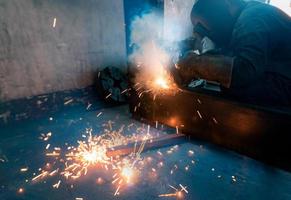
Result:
[231, 19, 268, 88]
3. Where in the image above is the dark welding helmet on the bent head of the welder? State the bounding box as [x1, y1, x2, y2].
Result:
[191, 0, 240, 47]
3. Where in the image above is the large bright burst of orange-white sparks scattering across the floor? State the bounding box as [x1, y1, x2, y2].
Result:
[32, 121, 163, 195]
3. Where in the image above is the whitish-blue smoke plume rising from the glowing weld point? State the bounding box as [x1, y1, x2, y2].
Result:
[130, 0, 195, 89]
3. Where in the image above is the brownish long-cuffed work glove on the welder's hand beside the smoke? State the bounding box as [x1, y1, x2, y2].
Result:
[172, 52, 233, 88]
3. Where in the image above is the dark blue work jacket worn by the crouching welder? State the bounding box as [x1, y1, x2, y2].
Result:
[228, 2, 291, 105]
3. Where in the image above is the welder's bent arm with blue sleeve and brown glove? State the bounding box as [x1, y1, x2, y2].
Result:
[172, 16, 269, 88]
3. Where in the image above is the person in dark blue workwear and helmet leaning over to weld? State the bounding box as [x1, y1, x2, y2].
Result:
[172, 0, 291, 106]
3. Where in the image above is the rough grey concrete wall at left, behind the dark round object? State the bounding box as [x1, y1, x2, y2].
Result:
[0, 0, 126, 101]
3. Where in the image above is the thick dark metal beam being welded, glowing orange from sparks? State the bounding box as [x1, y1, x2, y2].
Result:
[130, 87, 291, 170]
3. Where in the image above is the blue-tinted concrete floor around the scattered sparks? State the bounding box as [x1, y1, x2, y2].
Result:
[0, 106, 291, 200]
